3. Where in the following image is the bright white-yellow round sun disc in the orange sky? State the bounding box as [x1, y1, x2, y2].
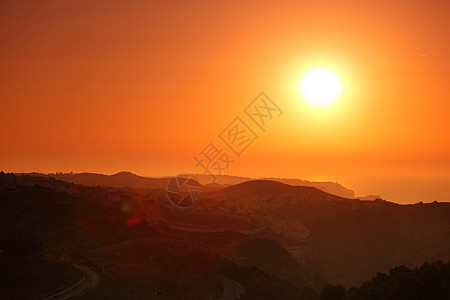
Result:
[298, 68, 344, 108]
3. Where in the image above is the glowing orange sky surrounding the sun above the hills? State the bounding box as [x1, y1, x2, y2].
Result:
[0, 0, 450, 203]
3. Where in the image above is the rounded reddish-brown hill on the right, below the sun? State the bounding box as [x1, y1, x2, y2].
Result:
[204, 181, 450, 286]
